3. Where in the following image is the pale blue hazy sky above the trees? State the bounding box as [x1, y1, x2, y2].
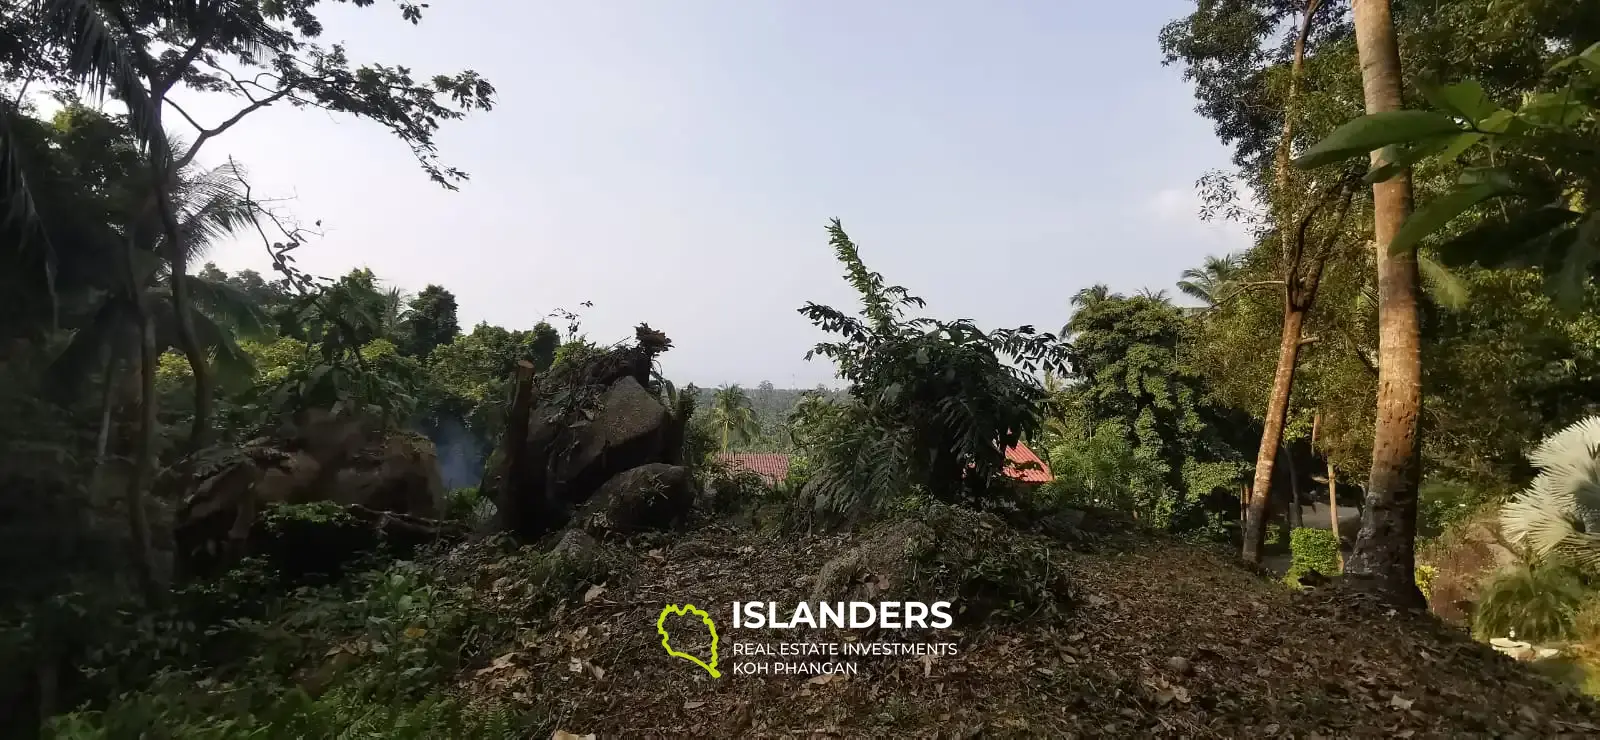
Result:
[174, 0, 1248, 388]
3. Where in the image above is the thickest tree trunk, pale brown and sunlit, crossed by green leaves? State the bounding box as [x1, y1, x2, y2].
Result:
[1346, 0, 1427, 607]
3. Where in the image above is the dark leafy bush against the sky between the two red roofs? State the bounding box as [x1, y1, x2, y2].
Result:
[800, 219, 1067, 514]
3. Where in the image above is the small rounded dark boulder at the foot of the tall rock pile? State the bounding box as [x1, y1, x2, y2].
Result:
[578, 463, 694, 533]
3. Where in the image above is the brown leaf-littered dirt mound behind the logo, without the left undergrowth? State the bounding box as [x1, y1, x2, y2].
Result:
[438, 517, 1600, 737]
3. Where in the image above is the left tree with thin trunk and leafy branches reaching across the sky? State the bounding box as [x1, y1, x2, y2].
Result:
[14, 0, 494, 474]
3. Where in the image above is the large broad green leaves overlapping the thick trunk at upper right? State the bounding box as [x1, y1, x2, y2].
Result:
[1294, 43, 1600, 308]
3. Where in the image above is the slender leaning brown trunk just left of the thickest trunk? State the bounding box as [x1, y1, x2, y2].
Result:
[1242, 0, 1322, 564]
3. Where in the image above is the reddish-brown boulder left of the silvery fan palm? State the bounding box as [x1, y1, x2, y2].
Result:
[1418, 506, 1522, 625]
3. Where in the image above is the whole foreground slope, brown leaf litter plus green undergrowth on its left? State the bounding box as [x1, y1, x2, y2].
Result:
[72, 508, 1600, 738]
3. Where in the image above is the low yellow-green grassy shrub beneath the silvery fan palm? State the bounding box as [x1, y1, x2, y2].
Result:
[1472, 562, 1589, 642]
